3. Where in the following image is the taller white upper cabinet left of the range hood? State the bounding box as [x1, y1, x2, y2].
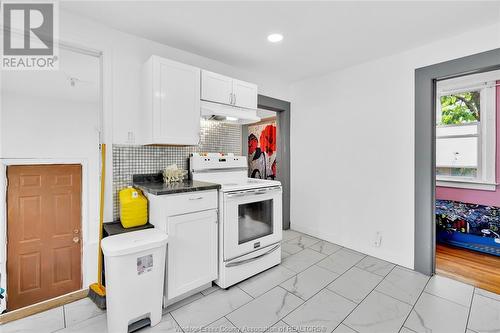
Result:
[141, 56, 200, 145]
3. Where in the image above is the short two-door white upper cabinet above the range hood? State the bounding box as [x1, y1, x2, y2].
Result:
[201, 70, 257, 109]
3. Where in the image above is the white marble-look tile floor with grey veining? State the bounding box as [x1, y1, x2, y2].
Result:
[0, 231, 500, 333]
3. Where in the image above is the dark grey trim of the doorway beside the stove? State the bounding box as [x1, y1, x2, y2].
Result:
[242, 95, 291, 230]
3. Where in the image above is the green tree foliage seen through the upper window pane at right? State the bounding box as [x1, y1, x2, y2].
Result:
[439, 91, 480, 125]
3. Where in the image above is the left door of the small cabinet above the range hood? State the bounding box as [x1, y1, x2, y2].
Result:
[201, 71, 233, 104]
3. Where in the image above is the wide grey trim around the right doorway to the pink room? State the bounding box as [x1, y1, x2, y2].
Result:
[415, 49, 500, 275]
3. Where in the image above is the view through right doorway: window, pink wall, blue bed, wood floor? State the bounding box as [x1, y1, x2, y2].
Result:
[435, 71, 500, 293]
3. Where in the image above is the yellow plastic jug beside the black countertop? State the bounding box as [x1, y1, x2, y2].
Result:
[119, 186, 148, 228]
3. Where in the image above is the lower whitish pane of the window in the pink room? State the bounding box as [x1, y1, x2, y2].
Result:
[436, 137, 478, 168]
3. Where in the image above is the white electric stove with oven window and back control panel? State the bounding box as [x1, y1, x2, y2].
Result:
[189, 154, 283, 288]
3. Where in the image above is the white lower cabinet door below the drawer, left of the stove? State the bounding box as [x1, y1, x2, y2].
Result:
[167, 209, 218, 299]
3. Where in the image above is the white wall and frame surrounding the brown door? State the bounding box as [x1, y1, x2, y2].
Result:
[0, 51, 99, 308]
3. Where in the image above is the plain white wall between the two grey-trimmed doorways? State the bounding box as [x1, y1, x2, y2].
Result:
[291, 24, 500, 268]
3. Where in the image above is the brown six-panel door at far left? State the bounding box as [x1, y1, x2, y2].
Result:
[7, 165, 82, 310]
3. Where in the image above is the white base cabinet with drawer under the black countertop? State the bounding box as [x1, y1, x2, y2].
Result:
[146, 190, 218, 305]
